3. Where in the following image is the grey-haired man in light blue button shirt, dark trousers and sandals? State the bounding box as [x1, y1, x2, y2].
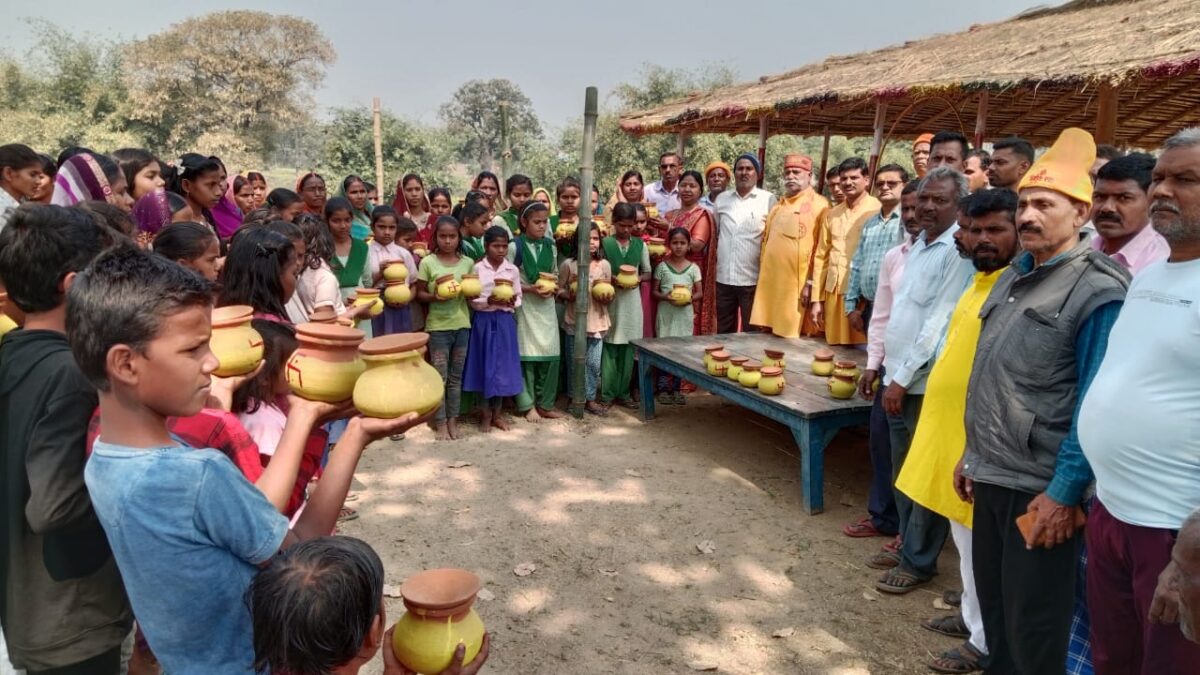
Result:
[868, 165, 971, 595]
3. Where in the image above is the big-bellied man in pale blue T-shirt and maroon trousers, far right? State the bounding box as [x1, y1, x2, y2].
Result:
[1079, 127, 1200, 675]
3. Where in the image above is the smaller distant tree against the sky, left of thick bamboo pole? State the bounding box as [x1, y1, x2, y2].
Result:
[438, 79, 541, 171]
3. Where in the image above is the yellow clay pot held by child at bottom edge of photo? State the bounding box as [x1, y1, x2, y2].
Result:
[391, 569, 484, 674]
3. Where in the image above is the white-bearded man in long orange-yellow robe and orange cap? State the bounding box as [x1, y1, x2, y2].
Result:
[750, 155, 829, 338]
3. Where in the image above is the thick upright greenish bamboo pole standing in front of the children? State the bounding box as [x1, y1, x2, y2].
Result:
[571, 86, 600, 418]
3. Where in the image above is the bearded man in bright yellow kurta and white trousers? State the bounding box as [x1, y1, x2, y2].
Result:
[896, 189, 1019, 671]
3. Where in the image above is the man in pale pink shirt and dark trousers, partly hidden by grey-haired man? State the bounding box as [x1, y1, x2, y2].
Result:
[841, 180, 920, 540]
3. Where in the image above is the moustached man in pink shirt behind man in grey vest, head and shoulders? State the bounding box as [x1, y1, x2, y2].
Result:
[1092, 153, 1171, 276]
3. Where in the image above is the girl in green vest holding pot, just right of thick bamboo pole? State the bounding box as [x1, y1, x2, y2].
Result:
[600, 202, 650, 408]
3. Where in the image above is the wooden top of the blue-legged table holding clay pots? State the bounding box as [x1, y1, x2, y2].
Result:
[634, 333, 871, 418]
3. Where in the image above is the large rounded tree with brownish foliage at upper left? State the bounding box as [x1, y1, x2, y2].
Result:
[125, 11, 335, 163]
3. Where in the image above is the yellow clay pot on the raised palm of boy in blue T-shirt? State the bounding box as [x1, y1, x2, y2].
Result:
[354, 333, 445, 419]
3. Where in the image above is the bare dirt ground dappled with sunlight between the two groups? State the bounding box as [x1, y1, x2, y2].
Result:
[341, 394, 958, 675]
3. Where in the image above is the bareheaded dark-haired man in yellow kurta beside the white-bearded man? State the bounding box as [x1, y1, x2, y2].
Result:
[809, 157, 882, 345]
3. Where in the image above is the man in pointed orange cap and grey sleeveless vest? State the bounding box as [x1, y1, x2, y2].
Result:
[954, 129, 1129, 674]
